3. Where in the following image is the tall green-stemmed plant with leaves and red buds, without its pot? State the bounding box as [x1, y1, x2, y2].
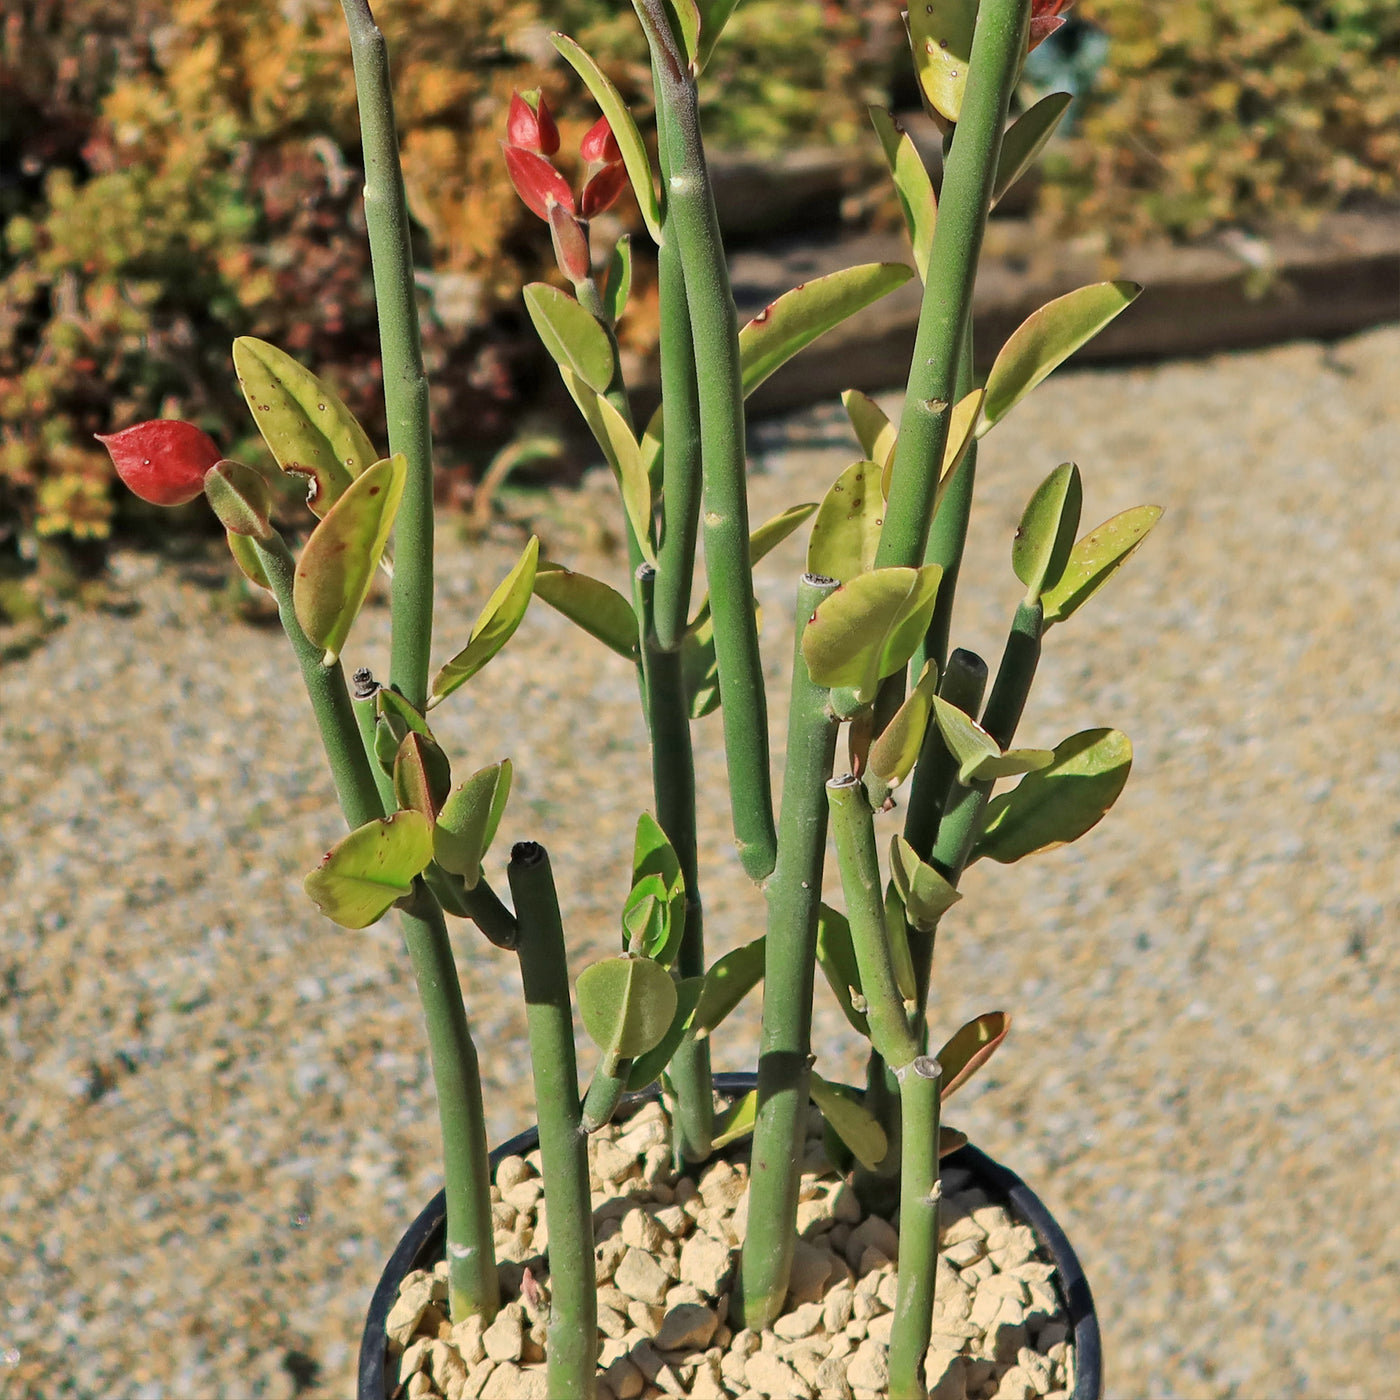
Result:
[102, 0, 1159, 1397]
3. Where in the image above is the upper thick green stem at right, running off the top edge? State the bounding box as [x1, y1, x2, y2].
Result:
[875, 0, 1030, 568]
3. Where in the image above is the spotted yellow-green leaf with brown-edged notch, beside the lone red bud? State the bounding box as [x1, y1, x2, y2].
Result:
[234, 336, 379, 515]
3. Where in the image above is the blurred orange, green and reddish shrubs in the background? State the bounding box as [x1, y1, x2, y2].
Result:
[0, 0, 1400, 602]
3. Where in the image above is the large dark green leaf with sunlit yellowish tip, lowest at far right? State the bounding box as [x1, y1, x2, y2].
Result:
[972, 729, 1133, 865]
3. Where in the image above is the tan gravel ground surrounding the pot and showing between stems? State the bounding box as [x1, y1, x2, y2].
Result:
[0, 328, 1400, 1400]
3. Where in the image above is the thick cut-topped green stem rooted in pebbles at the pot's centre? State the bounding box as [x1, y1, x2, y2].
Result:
[735, 574, 840, 1330]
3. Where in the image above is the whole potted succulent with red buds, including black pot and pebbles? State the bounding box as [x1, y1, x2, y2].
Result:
[104, 0, 1158, 1400]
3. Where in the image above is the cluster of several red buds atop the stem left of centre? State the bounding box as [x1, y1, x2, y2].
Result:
[501, 91, 627, 283]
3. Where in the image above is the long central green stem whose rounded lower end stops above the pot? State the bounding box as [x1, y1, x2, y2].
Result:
[636, 0, 777, 881]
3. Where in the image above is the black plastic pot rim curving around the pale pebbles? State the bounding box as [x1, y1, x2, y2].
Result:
[357, 1074, 1103, 1400]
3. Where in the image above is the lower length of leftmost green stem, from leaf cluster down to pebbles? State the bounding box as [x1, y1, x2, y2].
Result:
[399, 882, 501, 1322]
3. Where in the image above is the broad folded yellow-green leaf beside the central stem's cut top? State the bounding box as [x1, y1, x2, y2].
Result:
[802, 564, 942, 704]
